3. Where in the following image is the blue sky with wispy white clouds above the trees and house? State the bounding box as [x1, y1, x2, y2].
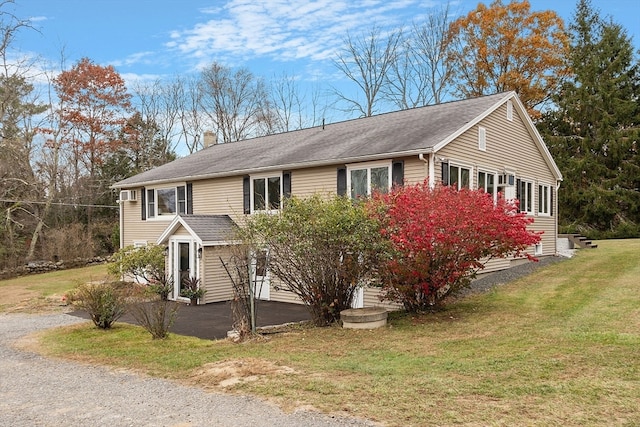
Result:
[11, 0, 640, 97]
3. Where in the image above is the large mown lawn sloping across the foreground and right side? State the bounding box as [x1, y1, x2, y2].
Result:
[30, 240, 640, 426]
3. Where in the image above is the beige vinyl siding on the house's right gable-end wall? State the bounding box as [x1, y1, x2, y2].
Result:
[435, 105, 557, 254]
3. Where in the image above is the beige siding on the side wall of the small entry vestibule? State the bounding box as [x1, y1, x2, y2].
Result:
[200, 246, 233, 303]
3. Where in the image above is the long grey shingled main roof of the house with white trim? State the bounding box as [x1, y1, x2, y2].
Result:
[113, 92, 560, 188]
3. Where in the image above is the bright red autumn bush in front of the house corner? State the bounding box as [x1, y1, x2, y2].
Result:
[368, 181, 540, 312]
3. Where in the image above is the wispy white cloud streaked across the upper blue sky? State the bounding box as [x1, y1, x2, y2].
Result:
[167, 0, 433, 63]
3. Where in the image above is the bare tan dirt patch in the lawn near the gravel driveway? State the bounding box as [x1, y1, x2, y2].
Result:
[188, 358, 297, 390]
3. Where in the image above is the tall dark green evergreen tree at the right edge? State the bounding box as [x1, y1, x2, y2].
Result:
[540, 0, 640, 238]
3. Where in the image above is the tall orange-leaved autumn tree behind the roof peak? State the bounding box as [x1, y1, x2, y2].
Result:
[449, 0, 569, 115]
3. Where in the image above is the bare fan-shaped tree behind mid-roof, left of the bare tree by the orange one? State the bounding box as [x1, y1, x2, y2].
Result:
[333, 26, 403, 117]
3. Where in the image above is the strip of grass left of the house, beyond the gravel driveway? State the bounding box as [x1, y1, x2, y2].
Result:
[0, 264, 107, 313]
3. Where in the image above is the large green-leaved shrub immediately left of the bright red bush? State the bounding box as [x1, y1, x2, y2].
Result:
[243, 195, 381, 326]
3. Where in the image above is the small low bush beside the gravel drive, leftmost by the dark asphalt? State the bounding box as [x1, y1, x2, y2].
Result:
[67, 282, 132, 329]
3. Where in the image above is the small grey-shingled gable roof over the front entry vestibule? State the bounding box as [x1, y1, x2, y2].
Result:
[156, 215, 237, 246]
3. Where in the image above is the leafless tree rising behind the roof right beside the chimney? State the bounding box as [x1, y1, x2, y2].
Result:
[200, 63, 274, 143]
